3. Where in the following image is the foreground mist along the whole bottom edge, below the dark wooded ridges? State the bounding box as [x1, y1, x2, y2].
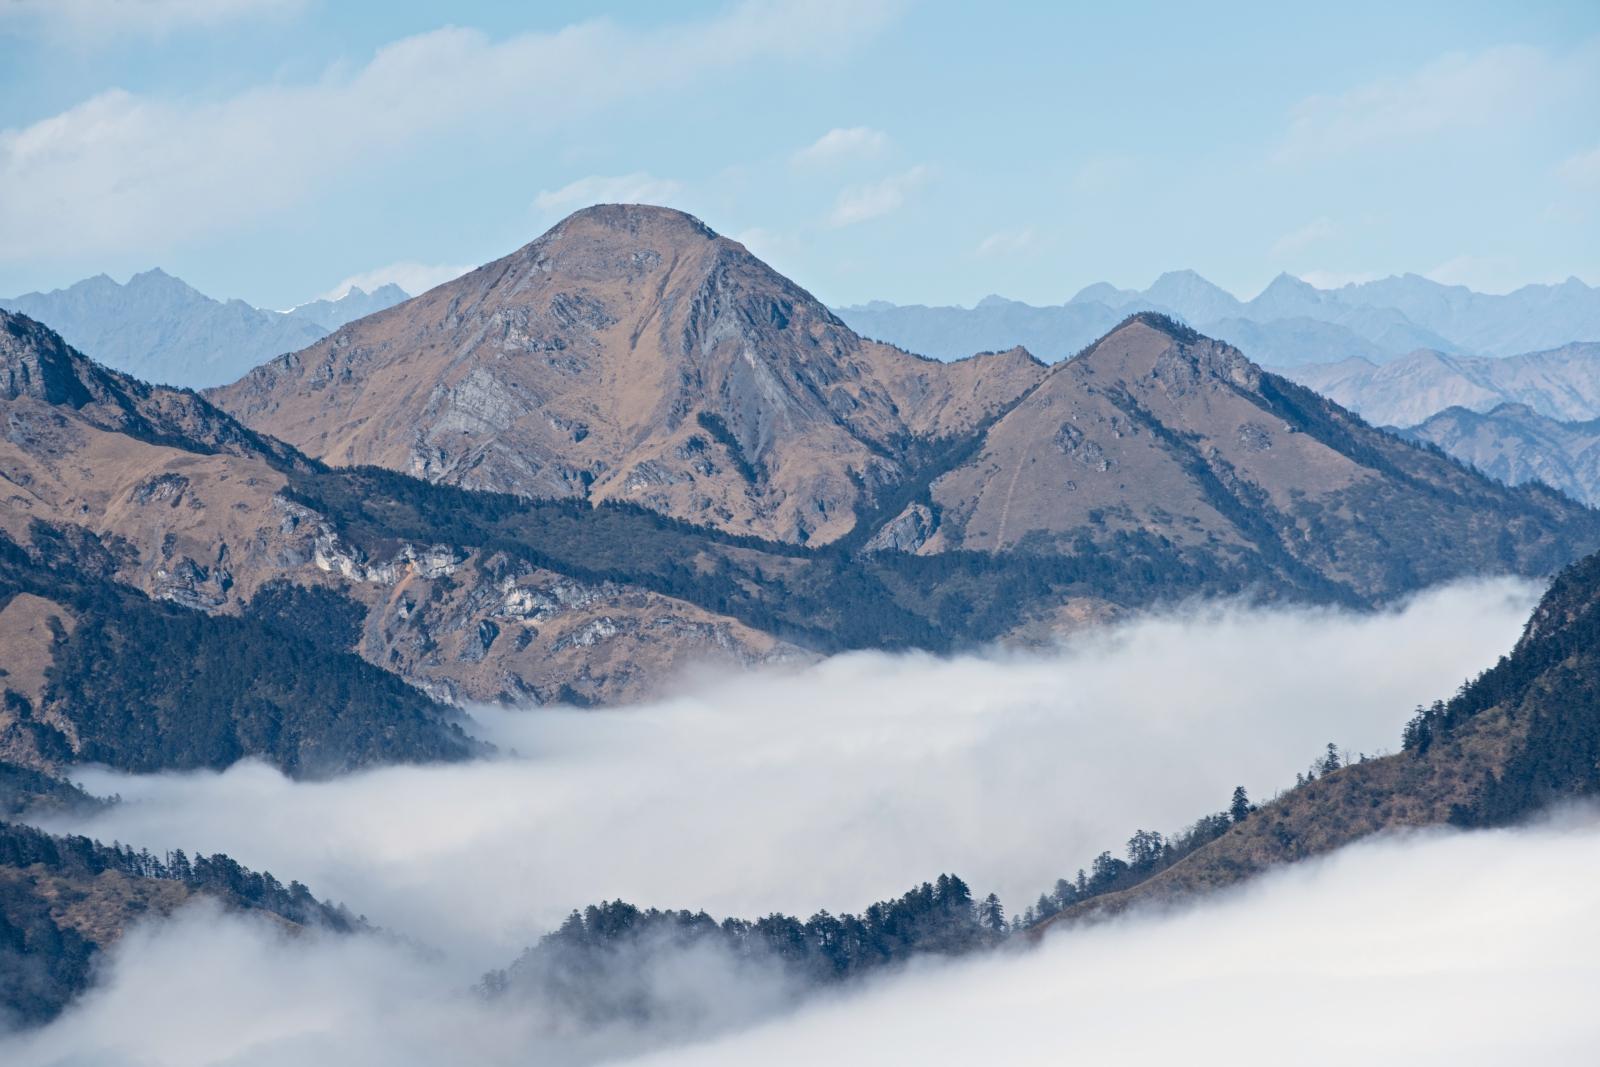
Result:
[0, 811, 1600, 1067]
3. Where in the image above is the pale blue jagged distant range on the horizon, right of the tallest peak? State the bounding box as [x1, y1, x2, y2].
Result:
[835, 270, 1600, 366]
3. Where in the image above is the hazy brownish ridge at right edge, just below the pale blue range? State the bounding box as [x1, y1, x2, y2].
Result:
[1283, 342, 1600, 426]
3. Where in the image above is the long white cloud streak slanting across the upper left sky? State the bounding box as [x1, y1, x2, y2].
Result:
[0, 0, 899, 261]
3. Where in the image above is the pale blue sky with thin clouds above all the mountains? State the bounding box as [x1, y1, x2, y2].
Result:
[0, 0, 1600, 307]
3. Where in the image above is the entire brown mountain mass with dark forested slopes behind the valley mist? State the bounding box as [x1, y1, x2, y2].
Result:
[0, 206, 1600, 773]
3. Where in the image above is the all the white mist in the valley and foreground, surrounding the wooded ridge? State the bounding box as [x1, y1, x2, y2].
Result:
[0, 581, 1600, 1064]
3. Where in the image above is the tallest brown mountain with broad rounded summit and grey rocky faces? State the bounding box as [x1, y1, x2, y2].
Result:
[211, 205, 1042, 544]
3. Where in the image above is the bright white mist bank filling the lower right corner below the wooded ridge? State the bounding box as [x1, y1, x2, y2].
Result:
[637, 811, 1600, 1067]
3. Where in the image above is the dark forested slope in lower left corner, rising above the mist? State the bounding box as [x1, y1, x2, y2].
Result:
[0, 821, 366, 1030]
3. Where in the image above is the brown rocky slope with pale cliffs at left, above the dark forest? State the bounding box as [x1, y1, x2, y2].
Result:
[0, 312, 792, 723]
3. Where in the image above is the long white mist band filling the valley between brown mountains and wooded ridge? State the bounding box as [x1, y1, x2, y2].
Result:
[40, 581, 1536, 981]
